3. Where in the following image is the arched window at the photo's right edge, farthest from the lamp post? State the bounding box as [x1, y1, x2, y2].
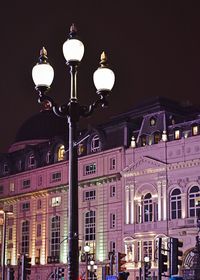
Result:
[189, 186, 200, 217]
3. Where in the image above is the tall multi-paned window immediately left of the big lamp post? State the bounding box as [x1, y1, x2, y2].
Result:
[51, 216, 60, 257]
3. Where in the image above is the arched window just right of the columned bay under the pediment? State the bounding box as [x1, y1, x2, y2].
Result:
[170, 189, 181, 219]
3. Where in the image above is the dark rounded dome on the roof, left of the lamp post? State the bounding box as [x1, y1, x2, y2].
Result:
[15, 110, 68, 143]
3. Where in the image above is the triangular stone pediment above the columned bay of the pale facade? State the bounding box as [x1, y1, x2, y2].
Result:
[122, 156, 166, 176]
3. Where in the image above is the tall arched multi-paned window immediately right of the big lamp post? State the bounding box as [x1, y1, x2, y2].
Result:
[85, 210, 96, 241]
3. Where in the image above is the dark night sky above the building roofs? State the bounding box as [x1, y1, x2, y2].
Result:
[0, 0, 200, 152]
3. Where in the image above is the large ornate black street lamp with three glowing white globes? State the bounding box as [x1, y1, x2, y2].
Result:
[32, 24, 115, 280]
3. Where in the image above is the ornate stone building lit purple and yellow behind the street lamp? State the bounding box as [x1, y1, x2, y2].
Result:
[0, 98, 200, 280]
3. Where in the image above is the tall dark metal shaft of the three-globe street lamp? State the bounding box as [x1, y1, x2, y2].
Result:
[68, 66, 79, 280]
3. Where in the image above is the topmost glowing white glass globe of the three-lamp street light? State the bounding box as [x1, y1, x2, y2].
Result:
[63, 38, 84, 62]
